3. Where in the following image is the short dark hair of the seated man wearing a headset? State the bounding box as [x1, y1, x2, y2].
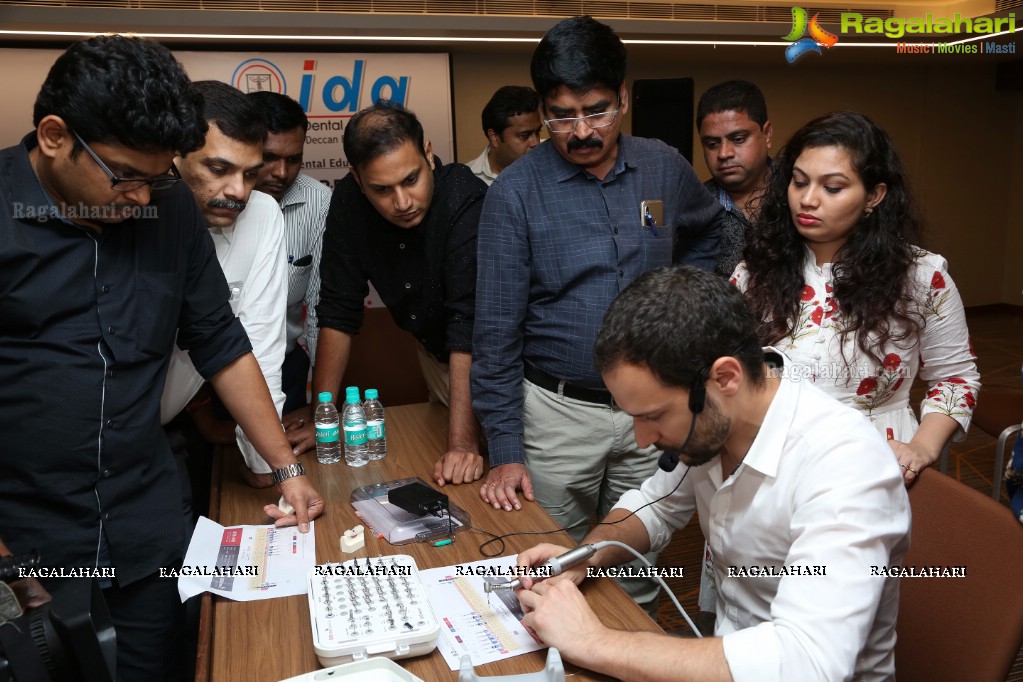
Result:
[593, 266, 765, 389]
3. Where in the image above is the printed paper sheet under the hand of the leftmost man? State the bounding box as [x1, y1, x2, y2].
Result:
[178, 516, 316, 601]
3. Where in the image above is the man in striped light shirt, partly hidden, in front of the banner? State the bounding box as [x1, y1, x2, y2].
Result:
[248, 90, 330, 427]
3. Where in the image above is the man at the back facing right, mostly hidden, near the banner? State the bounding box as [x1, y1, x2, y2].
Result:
[468, 85, 543, 185]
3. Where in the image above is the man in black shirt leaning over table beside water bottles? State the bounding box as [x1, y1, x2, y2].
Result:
[307, 101, 487, 486]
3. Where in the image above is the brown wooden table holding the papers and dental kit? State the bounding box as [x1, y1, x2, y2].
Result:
[195, 403, 661, 682]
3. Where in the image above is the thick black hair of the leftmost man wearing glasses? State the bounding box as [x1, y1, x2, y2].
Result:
[33, 36, 207, 154]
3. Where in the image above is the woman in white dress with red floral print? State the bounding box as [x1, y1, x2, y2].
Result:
[732, 112, 980, 486]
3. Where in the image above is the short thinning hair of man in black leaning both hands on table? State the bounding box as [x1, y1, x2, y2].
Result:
[343, 99, 427, 170]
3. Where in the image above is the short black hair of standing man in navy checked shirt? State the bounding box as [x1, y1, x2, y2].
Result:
[530, 16, 626, 98]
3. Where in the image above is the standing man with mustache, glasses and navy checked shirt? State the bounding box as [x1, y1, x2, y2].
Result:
[473, 16, 721, 608]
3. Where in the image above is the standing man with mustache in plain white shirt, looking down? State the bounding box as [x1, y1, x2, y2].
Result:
[161, 81, 287, 487]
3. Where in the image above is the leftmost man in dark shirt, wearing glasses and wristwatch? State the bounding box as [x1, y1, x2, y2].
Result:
[0, 36, 323, 681]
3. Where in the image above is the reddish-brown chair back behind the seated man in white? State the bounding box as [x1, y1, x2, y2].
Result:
[895, 469, 1023, 682]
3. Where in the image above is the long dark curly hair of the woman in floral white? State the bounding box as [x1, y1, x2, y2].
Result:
[744, 111, 921, 364]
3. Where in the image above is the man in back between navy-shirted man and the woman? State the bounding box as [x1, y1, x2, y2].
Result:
[697, 81, 772, 277]
